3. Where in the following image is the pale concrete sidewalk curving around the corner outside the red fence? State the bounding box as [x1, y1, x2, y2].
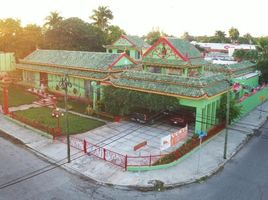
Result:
[0, 102, 268, 189]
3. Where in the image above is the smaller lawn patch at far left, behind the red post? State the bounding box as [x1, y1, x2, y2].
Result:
[0, 85, 38, 107]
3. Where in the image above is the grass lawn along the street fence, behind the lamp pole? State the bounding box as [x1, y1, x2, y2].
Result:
[15, 107, 105, 134]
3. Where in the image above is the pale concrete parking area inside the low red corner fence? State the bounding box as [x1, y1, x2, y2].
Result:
[79, 120, 194, 156]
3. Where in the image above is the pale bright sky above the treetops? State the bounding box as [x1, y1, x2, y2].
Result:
[0, 0, 268, 37]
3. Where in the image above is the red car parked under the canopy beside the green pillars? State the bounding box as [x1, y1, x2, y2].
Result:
[164, 110, 195, 126]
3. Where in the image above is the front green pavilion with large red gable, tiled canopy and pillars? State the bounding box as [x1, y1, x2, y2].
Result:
[111, 37, 230, 132]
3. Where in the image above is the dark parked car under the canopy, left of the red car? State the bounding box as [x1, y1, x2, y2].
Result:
[130, 109, 162, 124]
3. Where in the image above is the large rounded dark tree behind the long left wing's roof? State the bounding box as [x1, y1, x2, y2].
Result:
[43, 17, 105, 51]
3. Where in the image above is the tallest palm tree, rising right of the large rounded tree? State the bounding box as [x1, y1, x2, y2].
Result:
[90, 6, 114, 31]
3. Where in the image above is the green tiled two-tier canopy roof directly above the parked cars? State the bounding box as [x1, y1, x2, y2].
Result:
[112, 71, 229, 98]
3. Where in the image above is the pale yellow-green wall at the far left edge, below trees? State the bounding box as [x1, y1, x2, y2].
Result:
[0, 53, 16, 72]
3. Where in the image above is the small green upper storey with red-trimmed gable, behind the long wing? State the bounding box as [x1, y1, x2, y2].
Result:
[104, 35, 150, 60]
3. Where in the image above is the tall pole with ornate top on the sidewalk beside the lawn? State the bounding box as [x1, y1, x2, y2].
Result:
[59, 74, 72, 163]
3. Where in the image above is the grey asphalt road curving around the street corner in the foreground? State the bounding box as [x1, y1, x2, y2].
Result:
[0, 120, 268, 200]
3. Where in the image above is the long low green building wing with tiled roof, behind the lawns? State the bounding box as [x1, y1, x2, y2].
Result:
[16, 50, 136, 109]
